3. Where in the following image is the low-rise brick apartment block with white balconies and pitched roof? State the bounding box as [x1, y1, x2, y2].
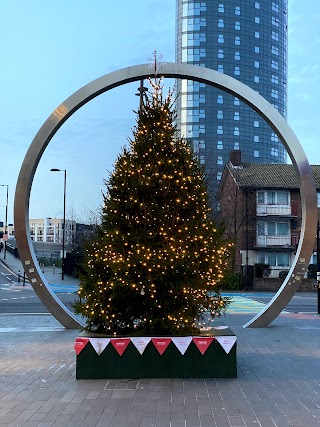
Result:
[217, 152, 320, 286]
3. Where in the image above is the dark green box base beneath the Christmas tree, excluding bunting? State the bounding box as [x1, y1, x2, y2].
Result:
[76, 329, 237, 379]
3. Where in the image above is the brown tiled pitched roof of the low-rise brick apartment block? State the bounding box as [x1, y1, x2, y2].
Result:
[227, 163, 320, 190]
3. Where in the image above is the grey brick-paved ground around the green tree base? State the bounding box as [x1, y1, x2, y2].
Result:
[0, 252, 320, 427]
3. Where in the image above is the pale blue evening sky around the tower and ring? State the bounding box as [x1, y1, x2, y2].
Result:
[0, 0, 320, 223]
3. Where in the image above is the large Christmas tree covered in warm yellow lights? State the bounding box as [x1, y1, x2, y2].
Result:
[74, 79, 229, 335]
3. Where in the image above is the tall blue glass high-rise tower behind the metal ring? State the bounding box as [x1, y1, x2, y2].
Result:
[176, 0, 287, 201]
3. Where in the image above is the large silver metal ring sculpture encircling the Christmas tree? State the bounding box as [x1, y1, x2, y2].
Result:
[14, 63, 317, 329]
